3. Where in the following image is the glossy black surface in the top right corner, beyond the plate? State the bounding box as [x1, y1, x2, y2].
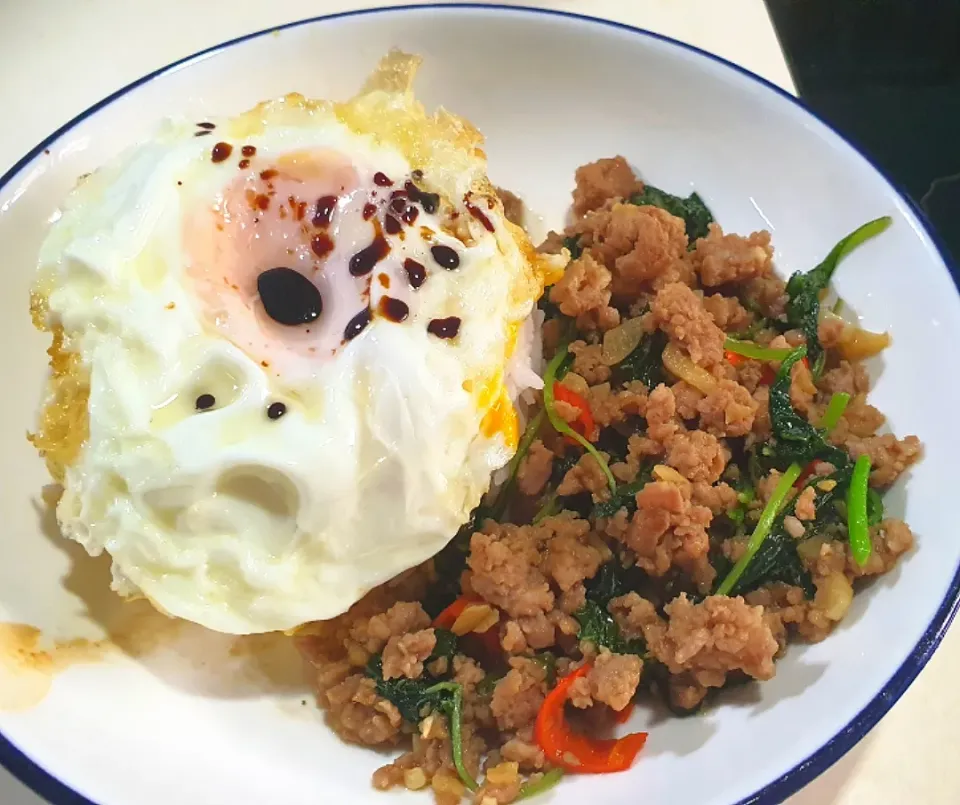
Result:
[766, 0, 960, 266]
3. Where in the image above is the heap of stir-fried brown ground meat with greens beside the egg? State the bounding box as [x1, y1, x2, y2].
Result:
[297, 157, 922, 805]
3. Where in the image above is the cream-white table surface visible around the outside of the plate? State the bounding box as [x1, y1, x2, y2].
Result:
[0, 0, 960, 805]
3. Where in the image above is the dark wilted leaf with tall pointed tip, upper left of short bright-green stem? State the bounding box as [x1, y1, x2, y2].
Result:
[763, 346, 850, 467]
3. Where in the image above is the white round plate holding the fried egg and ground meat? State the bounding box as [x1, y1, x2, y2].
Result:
[0, 6, 960, 805]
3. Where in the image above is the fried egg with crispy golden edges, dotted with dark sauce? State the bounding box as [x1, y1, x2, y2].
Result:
[31, 52, 562, 633]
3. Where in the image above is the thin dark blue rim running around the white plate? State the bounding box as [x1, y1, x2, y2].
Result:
[0, 3, 960, 805]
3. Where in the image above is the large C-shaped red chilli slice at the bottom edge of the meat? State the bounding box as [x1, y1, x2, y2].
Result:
[534, 663, 647, 774]
